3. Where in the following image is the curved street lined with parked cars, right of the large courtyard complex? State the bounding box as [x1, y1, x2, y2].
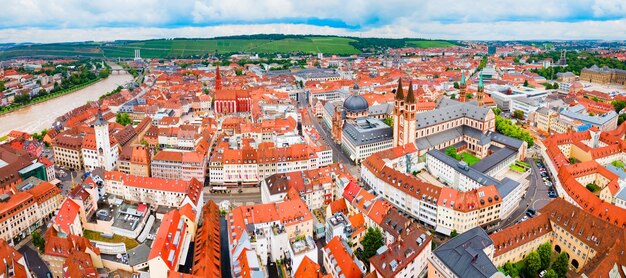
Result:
[500, 158, 552, 228]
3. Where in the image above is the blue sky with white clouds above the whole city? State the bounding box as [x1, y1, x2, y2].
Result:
[0, 0, 626, 43]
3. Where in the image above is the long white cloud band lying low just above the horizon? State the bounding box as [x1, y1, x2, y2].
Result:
[0, 19, 626, 42]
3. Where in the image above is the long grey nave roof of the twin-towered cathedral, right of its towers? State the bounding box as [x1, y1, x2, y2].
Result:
[416, 99, 490, 129]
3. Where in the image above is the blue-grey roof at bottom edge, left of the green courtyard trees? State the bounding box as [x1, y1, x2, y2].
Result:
[433, 227, 498, 278]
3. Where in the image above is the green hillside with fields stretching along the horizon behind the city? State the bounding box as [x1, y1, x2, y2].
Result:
[0, 35, 456, 59]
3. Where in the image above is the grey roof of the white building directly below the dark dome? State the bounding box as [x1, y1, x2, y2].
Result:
[343, 118, 393, 146]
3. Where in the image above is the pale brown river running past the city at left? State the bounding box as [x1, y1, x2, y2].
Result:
[0, 72, 133, 136]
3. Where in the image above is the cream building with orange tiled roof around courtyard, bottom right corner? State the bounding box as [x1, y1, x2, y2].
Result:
[490, 198, 625, 277]
